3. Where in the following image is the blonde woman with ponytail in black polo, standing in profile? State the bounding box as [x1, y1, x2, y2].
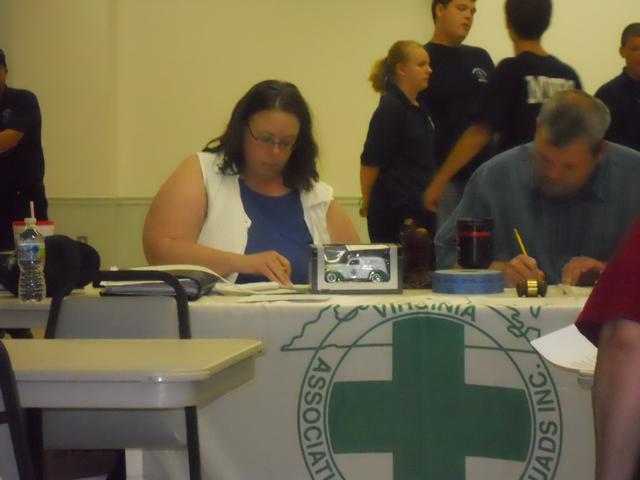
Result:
[360, 41, 436, 243]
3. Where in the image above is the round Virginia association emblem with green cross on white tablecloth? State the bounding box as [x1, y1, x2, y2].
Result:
[288, 302, 563, 480]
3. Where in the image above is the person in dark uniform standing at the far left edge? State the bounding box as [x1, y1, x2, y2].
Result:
[0, 50, 48, 251]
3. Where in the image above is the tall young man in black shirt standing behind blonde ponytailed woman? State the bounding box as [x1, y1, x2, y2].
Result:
[418, 0, 495, 226]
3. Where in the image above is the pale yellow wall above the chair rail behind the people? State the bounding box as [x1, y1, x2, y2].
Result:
[0, 0, 640, 198]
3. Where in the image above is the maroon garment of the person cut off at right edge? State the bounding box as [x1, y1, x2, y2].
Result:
[576, 224, 640, 345]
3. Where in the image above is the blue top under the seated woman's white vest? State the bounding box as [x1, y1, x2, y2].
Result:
[236, 178, 313, 283]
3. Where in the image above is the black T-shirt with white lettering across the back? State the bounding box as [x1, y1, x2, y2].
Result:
[477, 52, 582, 152]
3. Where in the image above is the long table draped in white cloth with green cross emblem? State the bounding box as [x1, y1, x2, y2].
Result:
[0, 289, 594, 480]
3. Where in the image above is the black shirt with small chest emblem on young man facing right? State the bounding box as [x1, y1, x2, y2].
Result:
[419, 42, 495, 181]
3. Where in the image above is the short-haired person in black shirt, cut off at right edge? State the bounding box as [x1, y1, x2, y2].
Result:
[596, 23, 640, 150]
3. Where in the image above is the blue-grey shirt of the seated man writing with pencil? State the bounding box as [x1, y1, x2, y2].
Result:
[435, 143, 640, 284]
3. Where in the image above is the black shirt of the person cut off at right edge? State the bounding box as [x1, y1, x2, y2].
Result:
[596, 69, 640, 150]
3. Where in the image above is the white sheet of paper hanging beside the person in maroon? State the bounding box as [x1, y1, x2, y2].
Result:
[531, 325, 598, 374]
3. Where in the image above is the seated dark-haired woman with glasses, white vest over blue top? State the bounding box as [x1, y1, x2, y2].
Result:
[144, 80, 359, 285]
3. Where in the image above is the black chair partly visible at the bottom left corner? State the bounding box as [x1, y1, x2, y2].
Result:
[0, 340, 36, 480]
